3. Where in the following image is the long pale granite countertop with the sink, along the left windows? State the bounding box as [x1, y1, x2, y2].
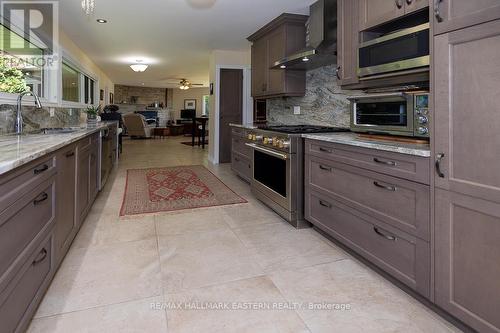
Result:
[0, 121, 117, 176]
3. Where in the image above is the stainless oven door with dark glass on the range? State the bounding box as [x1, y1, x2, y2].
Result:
[250, 144, 295, 211]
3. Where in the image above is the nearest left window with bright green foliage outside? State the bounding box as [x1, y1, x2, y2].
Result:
[0, 25, 45, 97]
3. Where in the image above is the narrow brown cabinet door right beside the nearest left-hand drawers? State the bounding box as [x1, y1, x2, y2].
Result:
[55, 146, 77, 262]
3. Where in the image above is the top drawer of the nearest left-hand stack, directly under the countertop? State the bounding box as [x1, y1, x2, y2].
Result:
[0, 155, 57, 212]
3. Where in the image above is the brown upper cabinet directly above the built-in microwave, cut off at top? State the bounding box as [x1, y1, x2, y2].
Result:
[359, 0, 429, 31]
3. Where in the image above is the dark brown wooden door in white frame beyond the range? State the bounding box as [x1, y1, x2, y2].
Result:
[219, 69, 243, 163]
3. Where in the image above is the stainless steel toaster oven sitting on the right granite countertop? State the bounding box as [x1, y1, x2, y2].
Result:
[349, 92, 430, 138]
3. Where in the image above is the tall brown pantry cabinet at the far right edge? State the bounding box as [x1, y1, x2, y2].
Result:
[433, 17, 500, 333]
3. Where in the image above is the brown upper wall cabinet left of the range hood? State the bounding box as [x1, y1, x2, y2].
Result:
[248, 14, 308, 98]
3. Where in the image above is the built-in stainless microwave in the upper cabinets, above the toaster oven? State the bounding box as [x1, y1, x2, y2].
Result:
[358, 23, 430, 77]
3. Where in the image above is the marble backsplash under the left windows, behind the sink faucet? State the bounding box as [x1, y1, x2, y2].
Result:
[0, 104, 81, 135]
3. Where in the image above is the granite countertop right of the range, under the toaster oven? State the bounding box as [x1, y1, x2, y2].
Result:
[302, 133, 431, 157]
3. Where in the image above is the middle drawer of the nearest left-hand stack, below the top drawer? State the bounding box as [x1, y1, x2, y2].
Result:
[0, 179, 55, 290]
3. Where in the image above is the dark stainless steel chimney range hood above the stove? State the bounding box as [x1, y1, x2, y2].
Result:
[271, 0, 337, 70]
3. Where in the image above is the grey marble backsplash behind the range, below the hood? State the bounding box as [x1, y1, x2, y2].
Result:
[267, 65, 362, 127]
